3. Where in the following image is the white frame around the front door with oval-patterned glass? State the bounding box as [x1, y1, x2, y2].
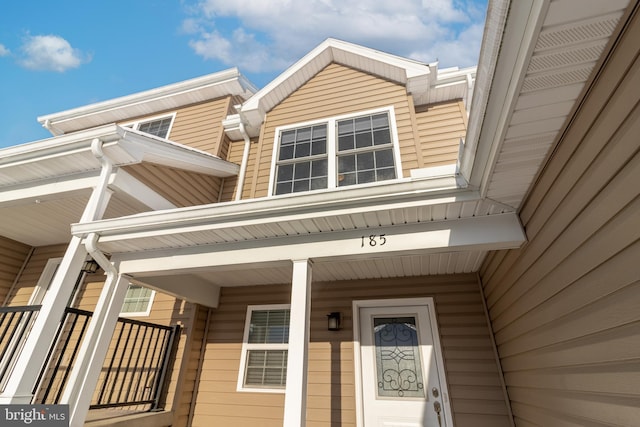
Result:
[352, 297, 453, 427]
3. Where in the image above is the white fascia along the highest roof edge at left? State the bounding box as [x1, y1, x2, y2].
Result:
[38, 68, 257, 133]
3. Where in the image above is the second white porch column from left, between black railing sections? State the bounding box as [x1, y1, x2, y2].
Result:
[61, 276, 129, 427]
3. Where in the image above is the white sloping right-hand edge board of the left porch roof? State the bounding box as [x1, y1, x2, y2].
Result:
[120, 128, 240, 177]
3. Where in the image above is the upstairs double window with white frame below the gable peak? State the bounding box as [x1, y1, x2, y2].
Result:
[271, 107, 400, 195]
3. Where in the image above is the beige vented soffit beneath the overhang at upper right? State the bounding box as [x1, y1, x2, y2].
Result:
[481, 0, 629, 208]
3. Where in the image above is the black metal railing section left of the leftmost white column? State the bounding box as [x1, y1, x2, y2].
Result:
[0, 305, 41, 390]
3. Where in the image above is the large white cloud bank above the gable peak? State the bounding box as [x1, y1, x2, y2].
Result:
[183, 0, 486, 72]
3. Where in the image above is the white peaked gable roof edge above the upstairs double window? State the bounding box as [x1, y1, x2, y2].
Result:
[235, 38, 476, 136]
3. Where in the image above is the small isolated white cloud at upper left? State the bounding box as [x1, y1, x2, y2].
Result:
[20, 35, 91, 72]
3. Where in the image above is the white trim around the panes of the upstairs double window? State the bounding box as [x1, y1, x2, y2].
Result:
[268, 105, 403, 197]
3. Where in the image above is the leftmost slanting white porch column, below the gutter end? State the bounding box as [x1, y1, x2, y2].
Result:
[0, 237, 87, 404]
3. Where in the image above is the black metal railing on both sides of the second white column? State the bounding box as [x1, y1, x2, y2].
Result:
[34, 308, 180, 410]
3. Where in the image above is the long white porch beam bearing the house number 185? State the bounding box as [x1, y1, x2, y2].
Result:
[118, 213, 526, 277]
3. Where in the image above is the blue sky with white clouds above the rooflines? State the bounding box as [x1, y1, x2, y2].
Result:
[0, 0, 486, 147]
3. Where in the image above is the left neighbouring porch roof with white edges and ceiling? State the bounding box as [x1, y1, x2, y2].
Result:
[0, 124, 239, 246]
